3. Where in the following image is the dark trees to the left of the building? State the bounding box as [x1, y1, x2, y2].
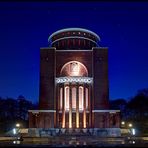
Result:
[0, 95, 38, 134]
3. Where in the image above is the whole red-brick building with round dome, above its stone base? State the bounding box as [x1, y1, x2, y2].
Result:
[29, 28, 120, 136]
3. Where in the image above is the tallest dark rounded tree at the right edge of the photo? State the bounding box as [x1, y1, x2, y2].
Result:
[127, 88, 148, 134]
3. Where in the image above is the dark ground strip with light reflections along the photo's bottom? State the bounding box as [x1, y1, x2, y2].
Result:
[0, 136, 148, 147]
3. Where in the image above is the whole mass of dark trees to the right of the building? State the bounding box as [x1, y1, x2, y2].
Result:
[110, 88, 148, 134]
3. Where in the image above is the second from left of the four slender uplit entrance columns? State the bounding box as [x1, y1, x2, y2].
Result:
[69, 84, 72, 128]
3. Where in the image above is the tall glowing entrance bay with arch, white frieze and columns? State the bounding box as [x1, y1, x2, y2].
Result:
[56, 61, 92, 128]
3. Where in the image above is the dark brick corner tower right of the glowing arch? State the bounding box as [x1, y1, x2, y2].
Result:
[92, 47, 109, 110]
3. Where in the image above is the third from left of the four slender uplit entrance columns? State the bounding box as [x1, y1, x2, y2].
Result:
[76, 83, 79, 128]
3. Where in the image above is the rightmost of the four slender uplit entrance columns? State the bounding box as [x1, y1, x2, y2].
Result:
[83, 85, 86, 128]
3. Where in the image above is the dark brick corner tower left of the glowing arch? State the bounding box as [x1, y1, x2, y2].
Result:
[39, 48, 55, 110]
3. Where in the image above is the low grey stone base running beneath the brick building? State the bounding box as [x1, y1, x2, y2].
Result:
[28, 128, 121, 137]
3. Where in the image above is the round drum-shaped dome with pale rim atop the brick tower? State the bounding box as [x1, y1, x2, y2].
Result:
[48, 28, 100, 50]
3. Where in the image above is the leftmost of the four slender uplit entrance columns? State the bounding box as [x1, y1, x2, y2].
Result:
[62, 84, 65, 128]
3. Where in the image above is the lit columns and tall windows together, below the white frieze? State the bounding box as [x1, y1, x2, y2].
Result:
[56, 83, 92, 128]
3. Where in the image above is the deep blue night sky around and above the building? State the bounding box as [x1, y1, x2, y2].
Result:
[0, 2, 148, 102]
